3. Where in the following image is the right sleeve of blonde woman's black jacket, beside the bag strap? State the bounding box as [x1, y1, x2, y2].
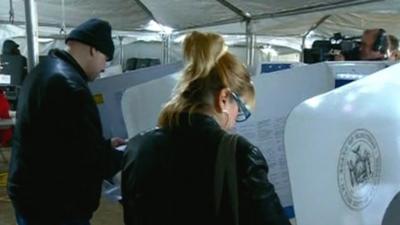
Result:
[236, 137, 290, 225]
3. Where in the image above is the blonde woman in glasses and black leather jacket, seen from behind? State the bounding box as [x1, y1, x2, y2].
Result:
[122, 31, 290, 225]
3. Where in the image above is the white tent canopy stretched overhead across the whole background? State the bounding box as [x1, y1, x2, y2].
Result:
[0, 0, 400, 62]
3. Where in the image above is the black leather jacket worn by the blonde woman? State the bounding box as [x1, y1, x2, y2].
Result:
[121, 113, 290, 225]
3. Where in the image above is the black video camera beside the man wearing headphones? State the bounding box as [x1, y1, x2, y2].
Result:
[303, 33, 361, 63]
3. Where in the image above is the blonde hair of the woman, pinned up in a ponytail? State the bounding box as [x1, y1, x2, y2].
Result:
[158, 31, 254, 128]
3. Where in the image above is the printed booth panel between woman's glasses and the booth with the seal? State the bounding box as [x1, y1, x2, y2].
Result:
[237, 63, 335, 218]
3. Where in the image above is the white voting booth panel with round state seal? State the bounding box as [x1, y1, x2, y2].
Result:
[285, 64, 400, 225]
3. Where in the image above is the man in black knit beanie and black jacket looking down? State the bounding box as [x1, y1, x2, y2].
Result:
[8, 19, 124, 225]
